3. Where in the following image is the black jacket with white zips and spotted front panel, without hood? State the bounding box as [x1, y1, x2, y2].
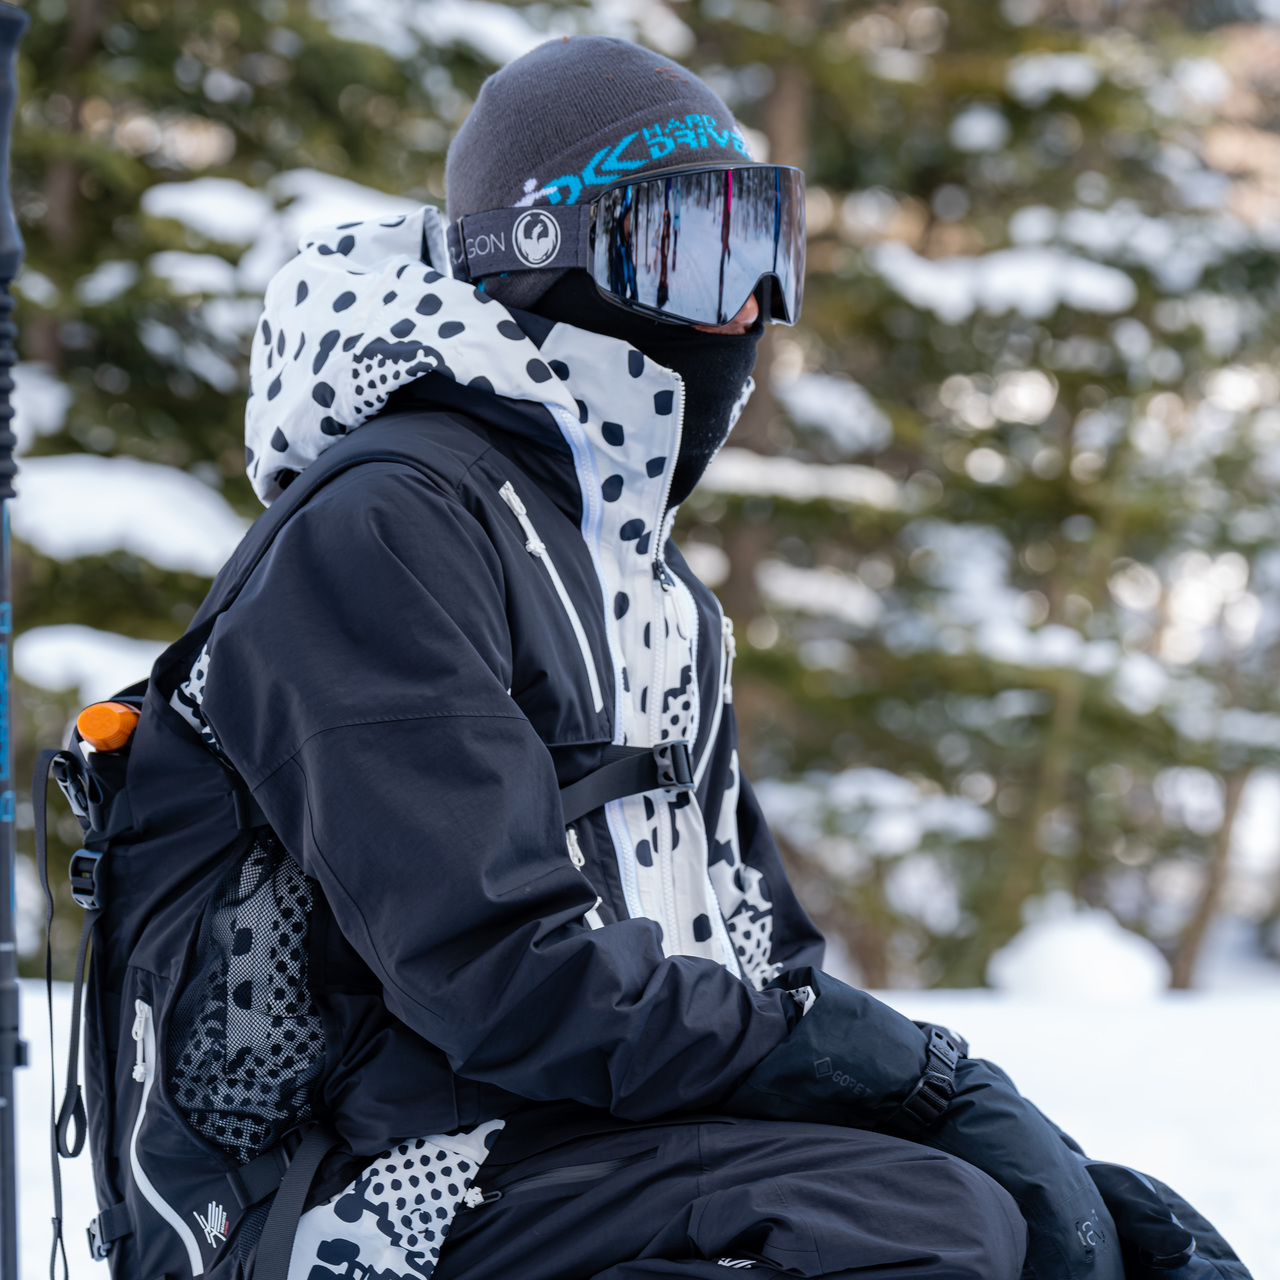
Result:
[201, 375, 822, 1153]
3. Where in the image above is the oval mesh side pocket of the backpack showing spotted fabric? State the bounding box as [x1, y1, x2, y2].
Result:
[168, 831, 324, 1164]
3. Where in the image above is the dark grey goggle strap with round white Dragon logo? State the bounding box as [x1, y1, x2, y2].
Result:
[448, 205, 591, 280]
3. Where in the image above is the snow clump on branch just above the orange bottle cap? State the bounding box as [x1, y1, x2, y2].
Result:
[13, 623, 165, 705]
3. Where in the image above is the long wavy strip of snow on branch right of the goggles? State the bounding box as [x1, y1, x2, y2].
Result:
[869, 242, 1138, 324]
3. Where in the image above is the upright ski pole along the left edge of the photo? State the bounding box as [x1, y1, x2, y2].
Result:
[0, 3, 28, 1280]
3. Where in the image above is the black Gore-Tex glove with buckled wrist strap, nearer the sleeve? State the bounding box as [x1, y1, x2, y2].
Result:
[723, 969, 1126, 1280]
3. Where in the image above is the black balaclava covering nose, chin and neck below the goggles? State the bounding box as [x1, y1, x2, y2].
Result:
[530, 268, 764, 507]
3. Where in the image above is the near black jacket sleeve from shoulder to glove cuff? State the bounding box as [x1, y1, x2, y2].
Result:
[204, 463, 797, 1119]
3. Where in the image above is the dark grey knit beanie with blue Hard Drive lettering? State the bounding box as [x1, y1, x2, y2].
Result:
[444, 36, 751, 307]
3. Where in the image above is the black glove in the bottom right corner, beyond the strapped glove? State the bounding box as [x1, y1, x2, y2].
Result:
[1085, 1161, 1249, 1280]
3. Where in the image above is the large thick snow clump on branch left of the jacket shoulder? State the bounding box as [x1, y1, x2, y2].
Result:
[13, 453, 248, 577]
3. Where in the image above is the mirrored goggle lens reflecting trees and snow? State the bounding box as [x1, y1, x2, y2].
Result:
[590, 165, 804, 324]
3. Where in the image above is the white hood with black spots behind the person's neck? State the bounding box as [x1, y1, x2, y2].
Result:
[244, 206, 711, 506]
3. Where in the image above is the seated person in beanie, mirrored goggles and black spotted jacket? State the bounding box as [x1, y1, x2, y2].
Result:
[166, 30, 1249, 1280]
